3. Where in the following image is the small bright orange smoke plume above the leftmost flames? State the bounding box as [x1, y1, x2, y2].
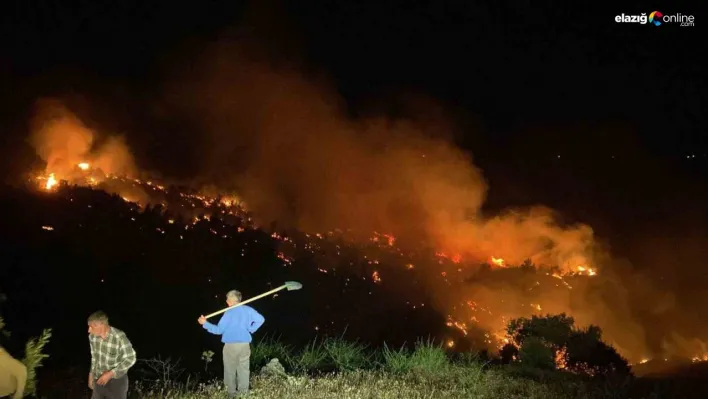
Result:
[30, 99, 136, 180]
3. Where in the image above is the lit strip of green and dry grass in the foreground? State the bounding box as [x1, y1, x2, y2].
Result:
[134, 339, 652, 399]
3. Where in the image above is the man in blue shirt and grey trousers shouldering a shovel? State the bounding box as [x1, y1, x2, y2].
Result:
[199, 290, 265, 397]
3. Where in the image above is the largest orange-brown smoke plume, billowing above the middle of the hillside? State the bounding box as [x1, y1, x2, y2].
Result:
[169, 44, 593, 270]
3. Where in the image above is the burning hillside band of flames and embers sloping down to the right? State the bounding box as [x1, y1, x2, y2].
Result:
[27, 155, 705, 361]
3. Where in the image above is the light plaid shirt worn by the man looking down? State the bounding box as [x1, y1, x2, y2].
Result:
[89, 327, 136, 378]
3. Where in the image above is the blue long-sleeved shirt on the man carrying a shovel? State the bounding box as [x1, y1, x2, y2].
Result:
[203, 305, 265, 344]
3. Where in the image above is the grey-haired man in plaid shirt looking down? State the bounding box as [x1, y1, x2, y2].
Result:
[88, 311, 136, 399]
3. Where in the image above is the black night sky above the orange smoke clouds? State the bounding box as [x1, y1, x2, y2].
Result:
[0, 0, 708, 233]
